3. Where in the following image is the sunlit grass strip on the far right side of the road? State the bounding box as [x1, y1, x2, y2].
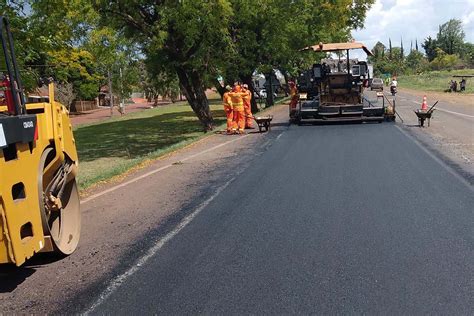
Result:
[398, 69, 474, 93]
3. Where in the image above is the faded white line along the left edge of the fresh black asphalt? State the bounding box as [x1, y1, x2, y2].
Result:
[84, 175, 237, 315]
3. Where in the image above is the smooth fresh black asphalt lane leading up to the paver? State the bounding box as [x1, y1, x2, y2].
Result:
[92, 123, 474, 315]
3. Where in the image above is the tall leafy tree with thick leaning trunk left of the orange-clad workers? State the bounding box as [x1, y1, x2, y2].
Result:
[95, 0, 233, 130]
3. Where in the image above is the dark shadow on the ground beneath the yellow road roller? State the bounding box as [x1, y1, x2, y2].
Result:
[0, 253, 64, 293]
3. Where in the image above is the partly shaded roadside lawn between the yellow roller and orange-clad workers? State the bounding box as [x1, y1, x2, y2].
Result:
[74, 100, 225, 189]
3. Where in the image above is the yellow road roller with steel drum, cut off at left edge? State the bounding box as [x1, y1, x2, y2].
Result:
[0, 16, 81, 266]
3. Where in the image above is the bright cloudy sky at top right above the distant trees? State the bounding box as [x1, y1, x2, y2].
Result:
[352, 0, 474, 59]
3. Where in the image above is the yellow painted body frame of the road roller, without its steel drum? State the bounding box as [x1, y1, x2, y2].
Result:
[0, 84, 80, 266]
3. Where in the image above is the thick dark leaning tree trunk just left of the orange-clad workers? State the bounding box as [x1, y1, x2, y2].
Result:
[176, 67, 213, 132]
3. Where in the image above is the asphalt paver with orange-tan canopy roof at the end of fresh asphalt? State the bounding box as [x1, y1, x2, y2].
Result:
[290, 42, 384, 123]
